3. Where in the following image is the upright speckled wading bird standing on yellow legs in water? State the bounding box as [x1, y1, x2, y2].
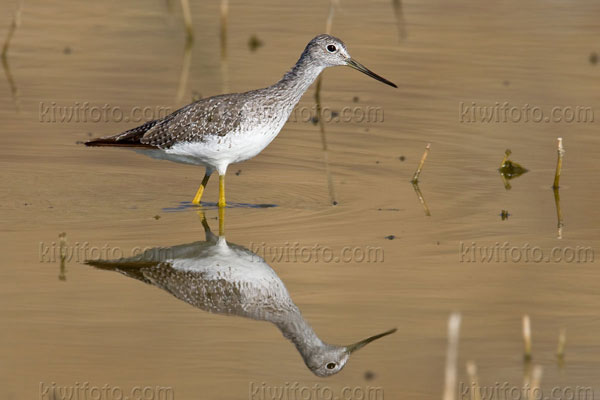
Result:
[86, 35, 397, 206]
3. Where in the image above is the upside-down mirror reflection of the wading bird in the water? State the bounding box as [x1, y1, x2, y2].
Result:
[86, 219, 396, 377]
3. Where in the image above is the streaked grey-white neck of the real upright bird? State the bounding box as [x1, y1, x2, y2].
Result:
[273, 53, 325, 108]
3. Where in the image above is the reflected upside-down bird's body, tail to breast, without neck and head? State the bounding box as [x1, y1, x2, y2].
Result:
[87, 241, 296, 322]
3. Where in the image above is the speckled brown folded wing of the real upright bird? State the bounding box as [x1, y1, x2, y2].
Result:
[141, 93, 245, 149]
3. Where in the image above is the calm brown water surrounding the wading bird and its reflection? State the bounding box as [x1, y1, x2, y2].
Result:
[0, 0, 600, 399]
